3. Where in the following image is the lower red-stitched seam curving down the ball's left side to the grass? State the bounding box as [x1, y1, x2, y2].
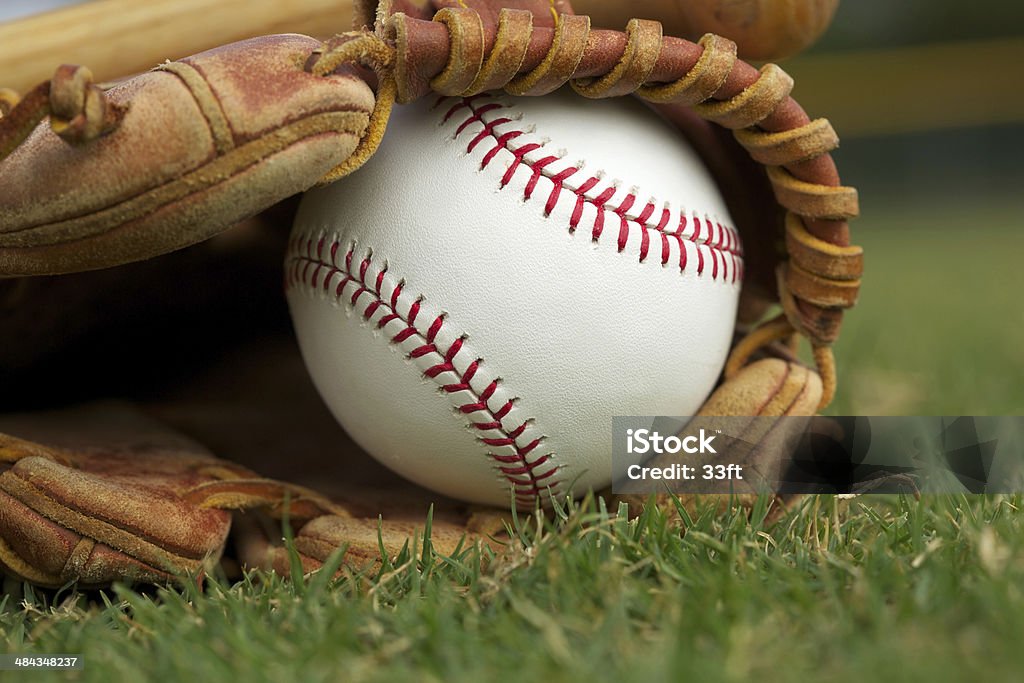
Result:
[285, 234, 562, 505]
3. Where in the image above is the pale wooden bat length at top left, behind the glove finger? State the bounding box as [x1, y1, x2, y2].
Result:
[0, 0, 352, 92]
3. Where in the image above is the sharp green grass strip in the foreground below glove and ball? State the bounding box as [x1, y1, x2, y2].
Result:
[0, 497, 1024, 682]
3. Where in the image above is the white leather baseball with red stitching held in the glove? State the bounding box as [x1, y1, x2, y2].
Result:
[286, 92, 742, 506]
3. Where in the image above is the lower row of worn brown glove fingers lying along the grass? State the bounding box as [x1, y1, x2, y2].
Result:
[0, 401, 503, 588]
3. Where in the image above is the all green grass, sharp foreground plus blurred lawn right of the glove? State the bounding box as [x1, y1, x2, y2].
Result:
[0, 198, 1024, 683]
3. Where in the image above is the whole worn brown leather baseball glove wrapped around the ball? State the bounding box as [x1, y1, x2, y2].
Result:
[0, 0, 862, 587]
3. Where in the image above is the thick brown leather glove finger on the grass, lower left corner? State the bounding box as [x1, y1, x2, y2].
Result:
[0, 405, 241, 587]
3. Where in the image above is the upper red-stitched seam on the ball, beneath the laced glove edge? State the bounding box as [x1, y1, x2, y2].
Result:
[435, 93, 743, 284]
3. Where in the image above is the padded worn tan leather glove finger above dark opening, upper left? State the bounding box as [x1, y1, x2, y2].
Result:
[0, 35, 375, 276]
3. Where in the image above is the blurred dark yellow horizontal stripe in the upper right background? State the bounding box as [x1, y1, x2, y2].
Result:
[783, 38, 1024, 138]
